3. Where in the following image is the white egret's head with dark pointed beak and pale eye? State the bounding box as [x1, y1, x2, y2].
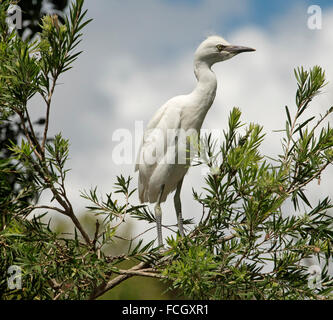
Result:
[195, 36, 255, 66]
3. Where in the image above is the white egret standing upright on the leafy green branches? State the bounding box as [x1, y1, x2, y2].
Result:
[135, 35, 255, 248]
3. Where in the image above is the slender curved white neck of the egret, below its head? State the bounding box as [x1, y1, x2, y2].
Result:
[192, 61, 217, 113]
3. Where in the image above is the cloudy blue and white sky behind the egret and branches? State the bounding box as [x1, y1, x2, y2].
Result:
[31, 0, 333, 244]
